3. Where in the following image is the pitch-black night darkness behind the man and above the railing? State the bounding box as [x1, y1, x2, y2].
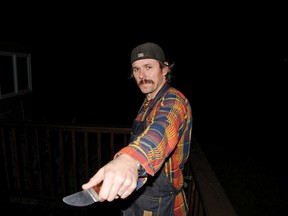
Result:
[0, 4, 288, 215]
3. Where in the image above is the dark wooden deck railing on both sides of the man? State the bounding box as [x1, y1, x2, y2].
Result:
[0, 123, 236, 216]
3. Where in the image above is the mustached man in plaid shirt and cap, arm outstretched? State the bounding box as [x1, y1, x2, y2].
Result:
[82, 42, 192, 216]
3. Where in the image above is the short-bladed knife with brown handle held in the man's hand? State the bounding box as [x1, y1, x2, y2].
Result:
[63, 183, 102, 207]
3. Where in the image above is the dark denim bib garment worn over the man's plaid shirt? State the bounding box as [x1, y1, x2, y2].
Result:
[122, 84, 181, 216]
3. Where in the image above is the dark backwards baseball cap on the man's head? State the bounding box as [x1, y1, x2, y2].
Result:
[131, 42, 165, 64]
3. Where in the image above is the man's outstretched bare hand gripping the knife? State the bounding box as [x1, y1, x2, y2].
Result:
[82, 154, 138, 201]
